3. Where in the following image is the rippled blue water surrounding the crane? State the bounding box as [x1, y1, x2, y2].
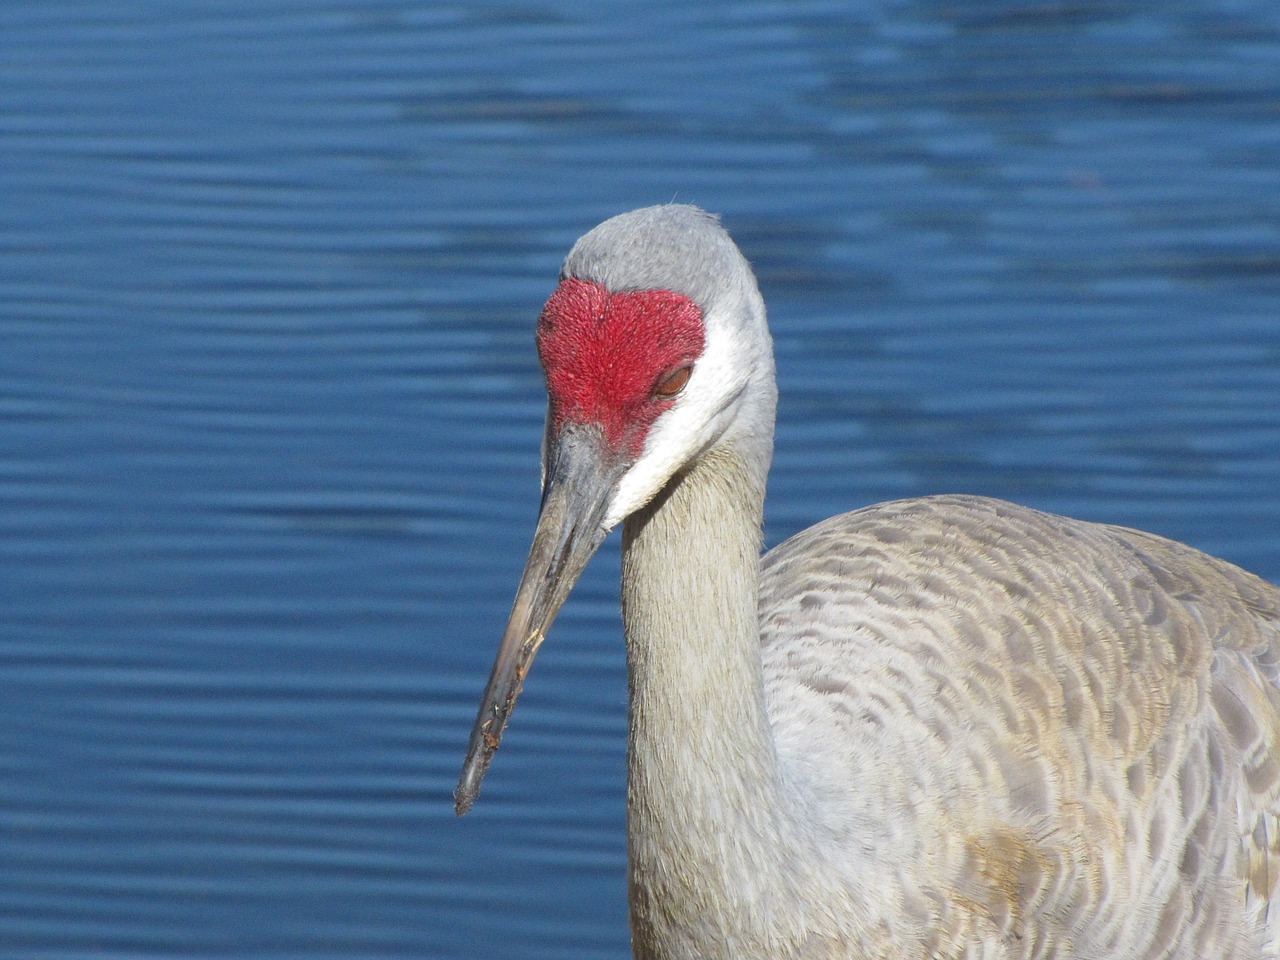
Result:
[0, 0, 1280, 960]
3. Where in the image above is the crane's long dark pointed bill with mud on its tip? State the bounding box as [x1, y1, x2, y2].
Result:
[453, 425, 626, 817]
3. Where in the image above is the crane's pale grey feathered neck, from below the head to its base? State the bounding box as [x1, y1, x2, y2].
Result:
[622, 444, 897, 960]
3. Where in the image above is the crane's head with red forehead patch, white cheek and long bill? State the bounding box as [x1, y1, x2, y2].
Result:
[454, 205, 776, 815]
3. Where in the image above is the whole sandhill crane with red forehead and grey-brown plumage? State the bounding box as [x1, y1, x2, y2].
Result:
[456, 205, 1280, 960]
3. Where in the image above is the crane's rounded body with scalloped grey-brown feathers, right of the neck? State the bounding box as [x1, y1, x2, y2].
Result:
[760, 497, 1280, 957]
